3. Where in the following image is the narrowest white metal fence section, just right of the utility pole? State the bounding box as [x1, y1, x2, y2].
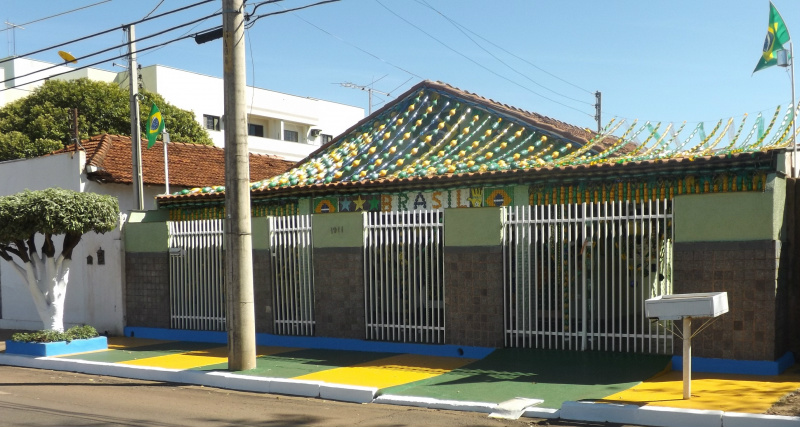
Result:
[269, 215, 314, 336]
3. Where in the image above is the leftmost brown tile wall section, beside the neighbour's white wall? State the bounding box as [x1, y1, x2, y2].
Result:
[125, 252, 169, 328]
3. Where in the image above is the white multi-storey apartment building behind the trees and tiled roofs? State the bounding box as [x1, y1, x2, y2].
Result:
[0, 58, 364, 161]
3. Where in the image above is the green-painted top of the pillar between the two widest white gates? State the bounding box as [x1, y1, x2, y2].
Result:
[444, 207, 503, 246]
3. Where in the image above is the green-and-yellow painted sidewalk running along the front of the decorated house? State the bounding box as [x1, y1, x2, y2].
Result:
[53, 338, 800, 414]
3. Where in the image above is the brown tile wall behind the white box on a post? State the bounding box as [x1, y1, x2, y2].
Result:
[673, 240, 788, 360]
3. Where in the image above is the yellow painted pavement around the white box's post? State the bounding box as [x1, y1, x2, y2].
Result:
[603, 370, 800, 414]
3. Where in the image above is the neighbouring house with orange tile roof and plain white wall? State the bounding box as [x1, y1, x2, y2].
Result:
[0, 134, 292, 334]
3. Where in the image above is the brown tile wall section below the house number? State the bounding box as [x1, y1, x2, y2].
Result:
[314, 248, 366, 339]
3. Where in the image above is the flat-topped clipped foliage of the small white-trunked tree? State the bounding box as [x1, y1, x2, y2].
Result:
[0, 188, 119, 263]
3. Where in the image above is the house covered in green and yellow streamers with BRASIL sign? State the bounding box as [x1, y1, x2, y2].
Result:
[125, 81, 798, 372]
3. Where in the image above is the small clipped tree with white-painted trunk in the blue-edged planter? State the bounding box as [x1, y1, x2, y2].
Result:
[0, 188, 119, 331]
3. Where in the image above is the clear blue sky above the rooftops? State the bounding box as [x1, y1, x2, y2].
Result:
[0, 0, 800, 135]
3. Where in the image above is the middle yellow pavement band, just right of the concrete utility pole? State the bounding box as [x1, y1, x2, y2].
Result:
[295, 354, 475, 388]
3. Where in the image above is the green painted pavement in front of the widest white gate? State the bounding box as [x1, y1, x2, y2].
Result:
[380, 349, 670, 409]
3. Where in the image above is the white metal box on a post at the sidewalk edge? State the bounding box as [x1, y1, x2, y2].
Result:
[644, 292, 728, 399]
